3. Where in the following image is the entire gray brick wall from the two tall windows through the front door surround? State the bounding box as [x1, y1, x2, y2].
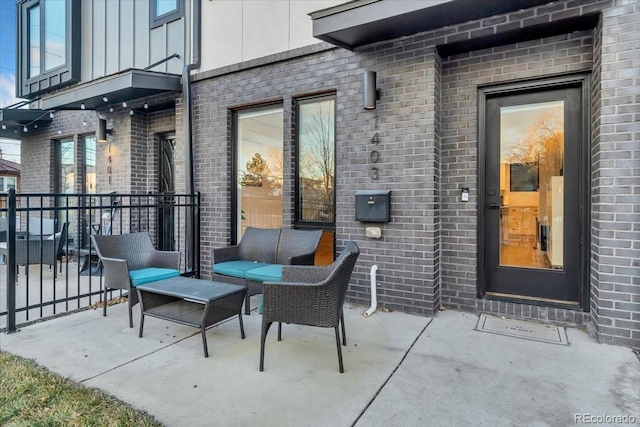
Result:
[188, 0, 637, 342]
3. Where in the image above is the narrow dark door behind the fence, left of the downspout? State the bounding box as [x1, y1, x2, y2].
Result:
[158, 135, 176, 251]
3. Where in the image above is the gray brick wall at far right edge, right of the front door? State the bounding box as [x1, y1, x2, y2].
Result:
[591, 1, 640, 346]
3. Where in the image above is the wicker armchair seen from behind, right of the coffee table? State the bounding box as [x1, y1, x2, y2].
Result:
[260, 241, 360, 373]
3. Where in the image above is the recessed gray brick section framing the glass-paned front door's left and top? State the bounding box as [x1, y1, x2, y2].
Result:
[441, 31, 593, 324]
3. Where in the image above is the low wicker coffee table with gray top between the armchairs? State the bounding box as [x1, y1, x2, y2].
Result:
[136, 276, 247, 357]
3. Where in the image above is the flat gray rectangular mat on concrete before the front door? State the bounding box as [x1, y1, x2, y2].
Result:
[475, 314, 569, 345]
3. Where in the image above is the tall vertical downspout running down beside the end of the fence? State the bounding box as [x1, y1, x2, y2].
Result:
[182, 0, 202, 274]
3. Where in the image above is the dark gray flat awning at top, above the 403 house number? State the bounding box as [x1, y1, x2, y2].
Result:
[309, 0, 552, 50]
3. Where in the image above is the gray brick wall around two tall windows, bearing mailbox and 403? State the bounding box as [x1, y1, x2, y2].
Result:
[193, 39, 448, 314]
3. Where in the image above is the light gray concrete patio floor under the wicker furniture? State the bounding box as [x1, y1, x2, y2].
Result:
[0, 304, 640, 427]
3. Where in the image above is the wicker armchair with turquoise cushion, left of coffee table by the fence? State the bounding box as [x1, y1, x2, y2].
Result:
[91, 233, 180, 328]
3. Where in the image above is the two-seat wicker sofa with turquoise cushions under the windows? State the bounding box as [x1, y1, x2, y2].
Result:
[212, 227, 322, 314]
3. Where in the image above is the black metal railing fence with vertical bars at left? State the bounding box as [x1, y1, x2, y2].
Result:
[0, 190, 200, 333]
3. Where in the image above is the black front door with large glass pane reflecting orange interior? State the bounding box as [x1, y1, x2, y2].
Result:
[481, 87, 583, 303]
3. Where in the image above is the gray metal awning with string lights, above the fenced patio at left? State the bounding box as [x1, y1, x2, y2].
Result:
[41, 69, 182, 110]
